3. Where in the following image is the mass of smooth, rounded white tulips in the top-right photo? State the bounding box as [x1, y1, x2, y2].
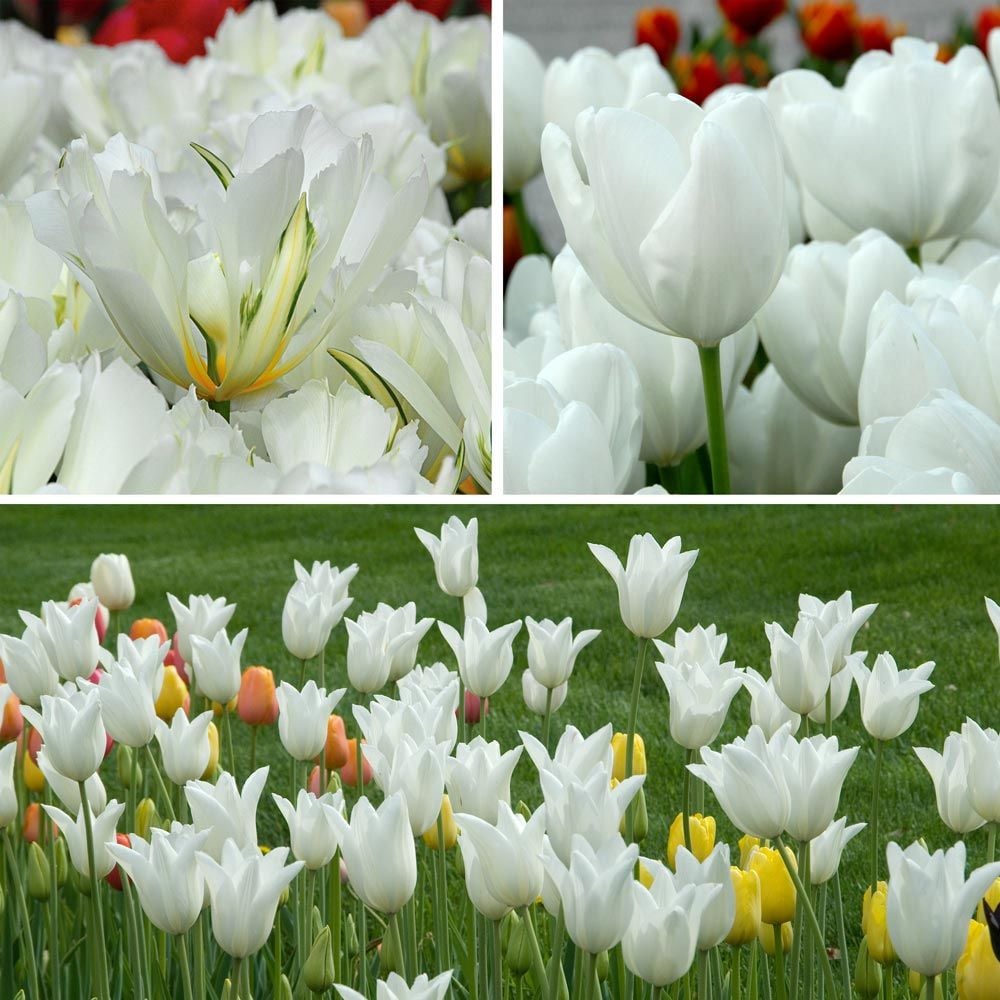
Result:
[504, 21, 1000, 494]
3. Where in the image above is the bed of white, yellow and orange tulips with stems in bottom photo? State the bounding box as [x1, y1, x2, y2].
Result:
[0, 517, 1000, 1000]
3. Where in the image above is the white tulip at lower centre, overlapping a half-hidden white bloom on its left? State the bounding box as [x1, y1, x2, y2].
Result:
[455, 802, 545, 910]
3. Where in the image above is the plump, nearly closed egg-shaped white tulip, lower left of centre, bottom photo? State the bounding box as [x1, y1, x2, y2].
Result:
[330, 792, 417, 916]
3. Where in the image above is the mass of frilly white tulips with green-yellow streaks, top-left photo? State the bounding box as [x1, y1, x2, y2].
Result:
[0, 2, 491, 494]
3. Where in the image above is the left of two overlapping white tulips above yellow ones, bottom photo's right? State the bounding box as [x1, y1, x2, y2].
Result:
[688, 726, 792, 840]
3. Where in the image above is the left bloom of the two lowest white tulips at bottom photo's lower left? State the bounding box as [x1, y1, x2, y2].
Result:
[108, 824, 208, 934]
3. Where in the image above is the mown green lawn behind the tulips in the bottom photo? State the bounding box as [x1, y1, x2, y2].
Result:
[0, 506, 1000, 956]
